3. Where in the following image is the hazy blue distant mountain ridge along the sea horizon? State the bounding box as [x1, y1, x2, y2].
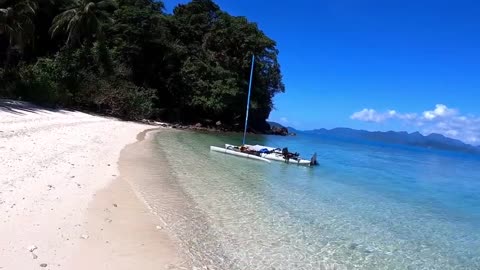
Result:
[305, 128, 480, 153]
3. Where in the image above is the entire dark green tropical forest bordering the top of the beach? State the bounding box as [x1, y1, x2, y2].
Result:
[0, 0, 284, 130]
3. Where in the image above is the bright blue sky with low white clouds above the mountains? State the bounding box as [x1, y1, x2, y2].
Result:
[165, 0, 480, 144]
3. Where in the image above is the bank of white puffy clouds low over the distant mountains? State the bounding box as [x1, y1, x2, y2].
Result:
[350, 104, 480, 145]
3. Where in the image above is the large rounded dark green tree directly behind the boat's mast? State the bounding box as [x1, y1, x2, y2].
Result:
[172, 0, 285, 130]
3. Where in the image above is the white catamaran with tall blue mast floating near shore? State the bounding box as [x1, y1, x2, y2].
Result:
[210, 55, 317, 166]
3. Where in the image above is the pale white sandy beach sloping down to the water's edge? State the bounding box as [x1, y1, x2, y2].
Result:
[0, 100, 183, 269]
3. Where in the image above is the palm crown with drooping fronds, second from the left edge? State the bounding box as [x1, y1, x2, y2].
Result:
[50, 0, 116, 46]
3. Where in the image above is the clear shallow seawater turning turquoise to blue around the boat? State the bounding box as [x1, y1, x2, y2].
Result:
[142, 131, 480, 269]
